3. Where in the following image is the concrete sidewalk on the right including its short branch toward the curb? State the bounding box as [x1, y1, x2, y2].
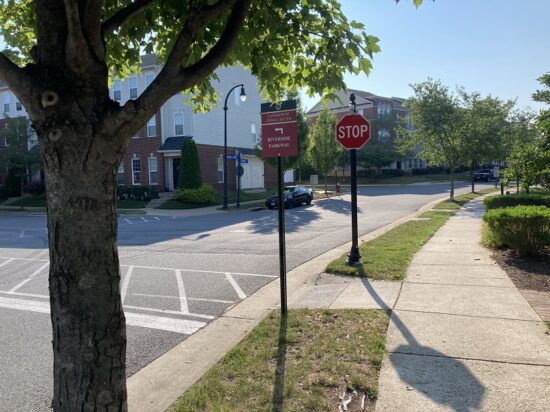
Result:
[297, 200, 550, 412]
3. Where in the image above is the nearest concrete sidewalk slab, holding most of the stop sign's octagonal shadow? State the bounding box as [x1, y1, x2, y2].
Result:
[376, 353, 550, 412]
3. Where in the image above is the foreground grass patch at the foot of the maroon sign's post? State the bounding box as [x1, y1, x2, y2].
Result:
[168, 309, 389, 412]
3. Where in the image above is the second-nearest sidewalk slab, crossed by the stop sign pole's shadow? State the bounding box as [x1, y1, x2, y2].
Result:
[386, 310, 550, 366]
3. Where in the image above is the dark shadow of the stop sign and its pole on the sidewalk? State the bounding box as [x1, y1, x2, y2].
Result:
[361, 278, 486, 412]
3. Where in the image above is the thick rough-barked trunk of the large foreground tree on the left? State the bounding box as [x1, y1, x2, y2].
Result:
[42, 128, 127, 411]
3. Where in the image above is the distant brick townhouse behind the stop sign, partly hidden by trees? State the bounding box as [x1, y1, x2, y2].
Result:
[306, 89, 426, 170]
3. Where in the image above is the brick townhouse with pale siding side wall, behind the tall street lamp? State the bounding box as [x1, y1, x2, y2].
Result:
[0, 55, 276, 192]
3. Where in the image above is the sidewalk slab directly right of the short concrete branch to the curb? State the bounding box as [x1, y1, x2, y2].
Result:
[395, 282, 540, 321]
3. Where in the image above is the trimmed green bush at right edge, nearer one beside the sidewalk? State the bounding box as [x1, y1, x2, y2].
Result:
[483, 206, 550, 255]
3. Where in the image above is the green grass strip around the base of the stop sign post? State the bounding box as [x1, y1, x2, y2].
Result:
[325, 212, 452, 280]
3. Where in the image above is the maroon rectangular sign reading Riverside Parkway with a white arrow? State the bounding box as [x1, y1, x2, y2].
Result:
[261, 100, 298, 157]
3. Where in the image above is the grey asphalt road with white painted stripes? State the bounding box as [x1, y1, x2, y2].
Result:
[0, 184, 496, 412]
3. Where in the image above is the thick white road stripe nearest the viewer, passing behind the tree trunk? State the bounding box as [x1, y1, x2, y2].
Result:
[0, 297, 206, 335]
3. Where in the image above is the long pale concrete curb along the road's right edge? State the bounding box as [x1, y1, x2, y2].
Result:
[127, 196, 447, 412]
